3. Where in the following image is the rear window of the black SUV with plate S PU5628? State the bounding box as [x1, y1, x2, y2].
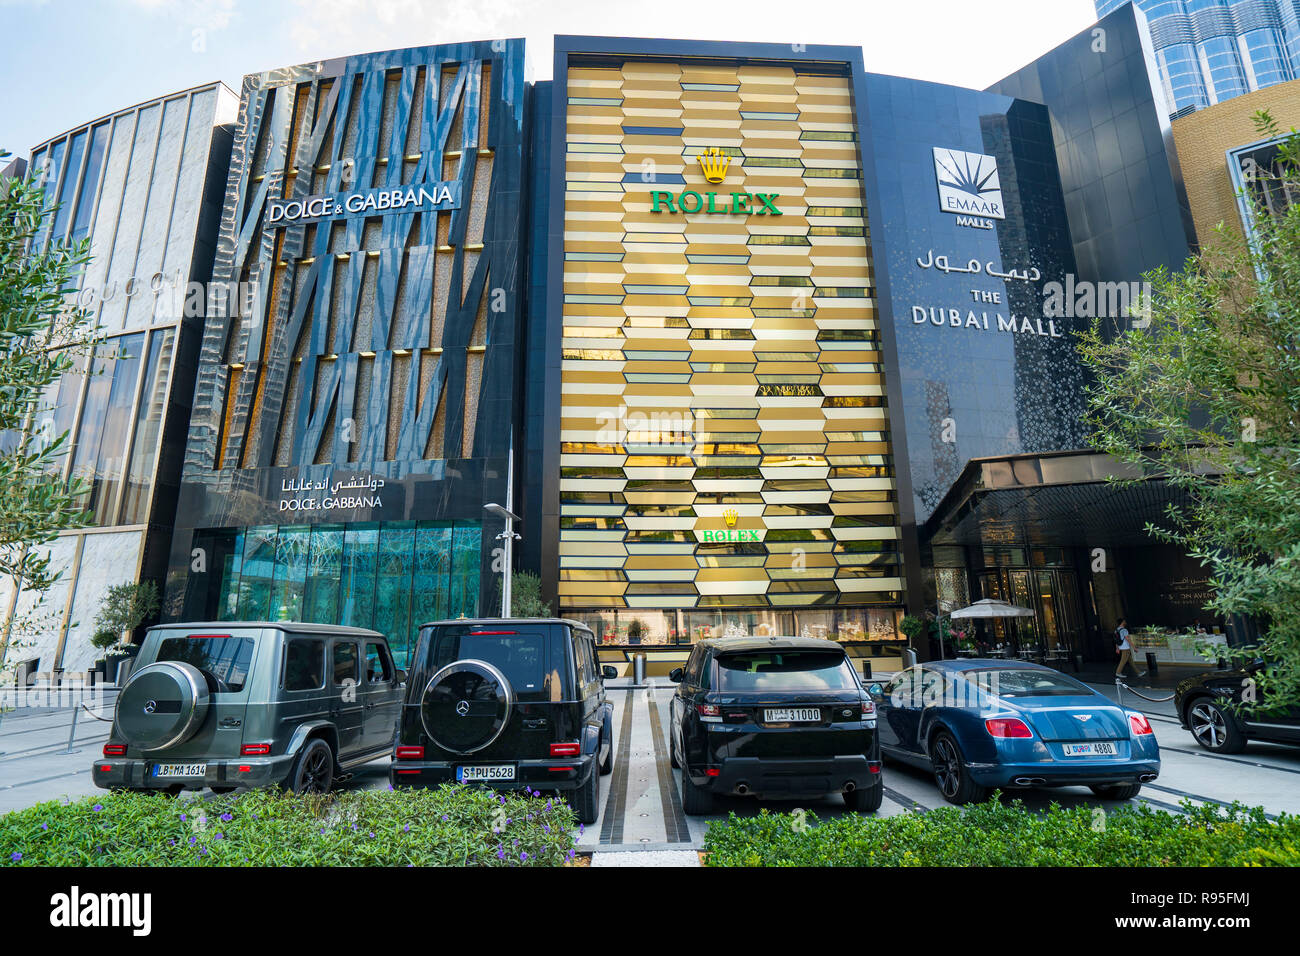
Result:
[425, 624, 568, 701]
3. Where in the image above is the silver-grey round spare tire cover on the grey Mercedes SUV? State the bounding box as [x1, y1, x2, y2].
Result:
[116, 661, 208, 750]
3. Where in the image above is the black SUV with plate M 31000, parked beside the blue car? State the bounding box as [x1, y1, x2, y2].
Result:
[668, 637, 884, 814]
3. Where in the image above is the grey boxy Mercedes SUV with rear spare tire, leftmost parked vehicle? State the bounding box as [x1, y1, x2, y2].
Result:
[91, 622, 406, 793]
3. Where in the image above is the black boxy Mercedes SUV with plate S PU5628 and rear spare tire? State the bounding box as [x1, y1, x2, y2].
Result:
[390, 618, 616, 823]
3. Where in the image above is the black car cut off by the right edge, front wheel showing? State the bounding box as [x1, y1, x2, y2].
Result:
[1174, 661, 1300, 753]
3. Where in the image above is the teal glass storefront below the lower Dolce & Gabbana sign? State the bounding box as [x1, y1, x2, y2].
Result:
[186, 522, 482, 667]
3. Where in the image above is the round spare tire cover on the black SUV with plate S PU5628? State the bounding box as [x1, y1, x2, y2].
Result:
[420, 661, 515, 753]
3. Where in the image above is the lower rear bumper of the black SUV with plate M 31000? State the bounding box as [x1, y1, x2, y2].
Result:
[690, 753, 883, 797]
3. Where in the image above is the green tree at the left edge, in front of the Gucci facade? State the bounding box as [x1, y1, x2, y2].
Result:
[0, 150, 95, 665]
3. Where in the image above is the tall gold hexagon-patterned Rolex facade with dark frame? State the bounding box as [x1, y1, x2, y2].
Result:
[541, 38, 904, 659]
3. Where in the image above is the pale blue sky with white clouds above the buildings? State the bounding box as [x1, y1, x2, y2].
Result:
[0, 0, 1097, 156]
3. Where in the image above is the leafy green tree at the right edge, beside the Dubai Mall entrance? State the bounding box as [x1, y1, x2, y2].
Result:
[1080, 113, 1300, 706]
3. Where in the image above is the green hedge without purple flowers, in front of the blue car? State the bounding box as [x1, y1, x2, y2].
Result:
[703, 799, 1300, 866]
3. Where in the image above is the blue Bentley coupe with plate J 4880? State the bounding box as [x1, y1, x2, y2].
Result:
[871, 659, 1160, 804]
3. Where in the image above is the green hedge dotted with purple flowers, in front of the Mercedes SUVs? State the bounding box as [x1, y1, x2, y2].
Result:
[0, 786, 576, 866]
